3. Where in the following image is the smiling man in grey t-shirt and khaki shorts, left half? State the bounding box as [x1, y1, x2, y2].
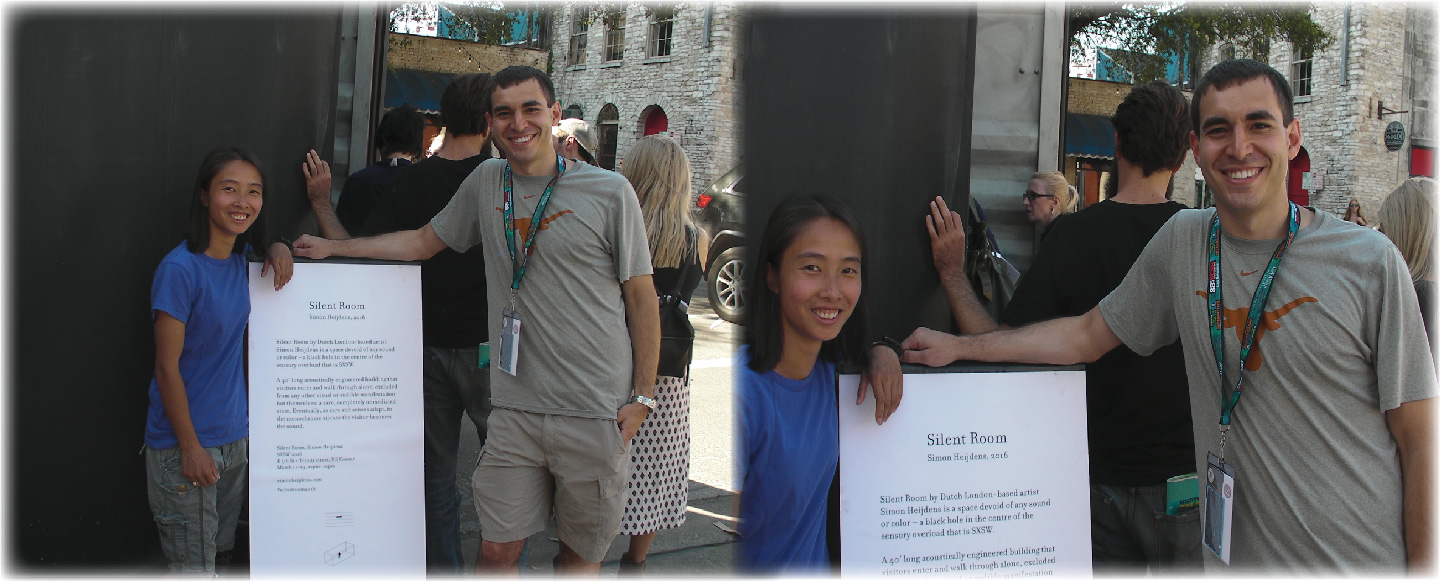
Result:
[295, 66, 660, 574]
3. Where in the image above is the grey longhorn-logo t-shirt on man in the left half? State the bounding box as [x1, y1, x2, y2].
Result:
[431, 160, 651, 420]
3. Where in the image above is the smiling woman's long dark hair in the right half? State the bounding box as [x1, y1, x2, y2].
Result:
[744, 195, 870, 373]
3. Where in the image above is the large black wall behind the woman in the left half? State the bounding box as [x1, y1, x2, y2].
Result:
[4, 7, 341, 568]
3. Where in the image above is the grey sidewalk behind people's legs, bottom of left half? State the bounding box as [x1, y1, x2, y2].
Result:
[462, 480, 736, 577]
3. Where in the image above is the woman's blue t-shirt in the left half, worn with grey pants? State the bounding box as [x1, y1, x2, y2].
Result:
[145, 242, 251, 448]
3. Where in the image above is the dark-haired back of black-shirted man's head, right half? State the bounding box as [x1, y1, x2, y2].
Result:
[1110, 81, 1191, 176]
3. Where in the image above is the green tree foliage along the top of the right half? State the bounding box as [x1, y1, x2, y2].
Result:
[1070, 1, 1333, 84]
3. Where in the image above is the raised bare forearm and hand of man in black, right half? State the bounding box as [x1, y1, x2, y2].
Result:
[924, 196, 1001, 334]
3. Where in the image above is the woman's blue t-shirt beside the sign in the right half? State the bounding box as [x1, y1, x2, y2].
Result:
[736, 347, 840, 574]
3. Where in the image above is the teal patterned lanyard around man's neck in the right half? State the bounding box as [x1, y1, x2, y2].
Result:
[1207, 202, 1300, 458]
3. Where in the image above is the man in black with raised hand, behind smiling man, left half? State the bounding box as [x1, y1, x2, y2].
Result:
[304, 72, 491, 572]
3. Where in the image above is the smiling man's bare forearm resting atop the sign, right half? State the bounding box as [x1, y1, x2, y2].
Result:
[900, 307, 1120, 368]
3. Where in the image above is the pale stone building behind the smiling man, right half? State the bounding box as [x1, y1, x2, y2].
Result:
[1202, 3, 1437, 218]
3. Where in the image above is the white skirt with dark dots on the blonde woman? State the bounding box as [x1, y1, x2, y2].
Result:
[621, 376, 690, 535]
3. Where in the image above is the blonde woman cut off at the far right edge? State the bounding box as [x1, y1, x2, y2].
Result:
[1376, 177, 1436, 356]
